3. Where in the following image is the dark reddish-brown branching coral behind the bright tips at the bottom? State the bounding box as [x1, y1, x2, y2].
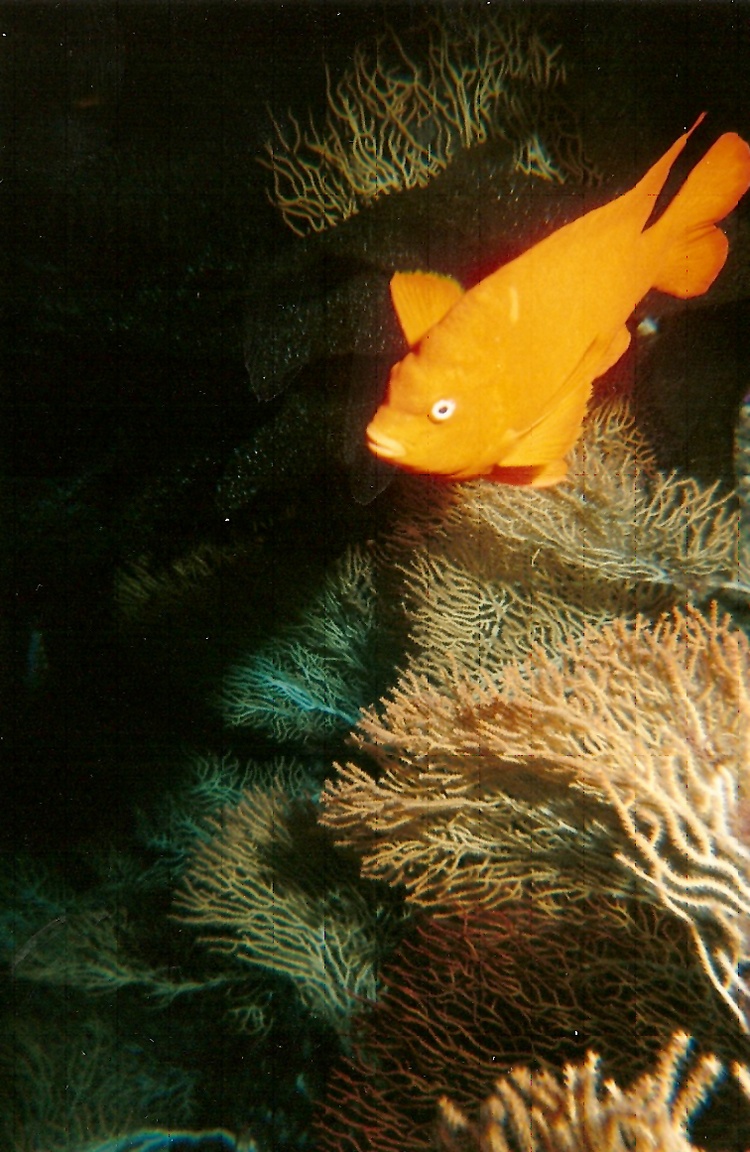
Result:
[318, 899, 750, 1152]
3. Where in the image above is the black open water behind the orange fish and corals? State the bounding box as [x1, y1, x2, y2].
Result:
[0, 2, 750, 1152]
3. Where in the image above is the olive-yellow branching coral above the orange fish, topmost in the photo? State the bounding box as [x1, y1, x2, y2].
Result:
[260, 10, 591, 235]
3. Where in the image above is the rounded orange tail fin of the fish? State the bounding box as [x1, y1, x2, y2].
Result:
[649, 132, 750, 300]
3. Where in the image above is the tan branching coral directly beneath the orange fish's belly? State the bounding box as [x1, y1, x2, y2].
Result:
[468, 402, 738, 596]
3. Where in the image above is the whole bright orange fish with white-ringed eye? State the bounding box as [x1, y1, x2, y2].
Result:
[366, 113, 750, 487]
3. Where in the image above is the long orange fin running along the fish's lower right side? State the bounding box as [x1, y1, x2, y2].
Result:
[498, 326, 630, 467]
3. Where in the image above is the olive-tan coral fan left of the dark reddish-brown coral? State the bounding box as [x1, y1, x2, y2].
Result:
[175, 788, 396, 1032]
